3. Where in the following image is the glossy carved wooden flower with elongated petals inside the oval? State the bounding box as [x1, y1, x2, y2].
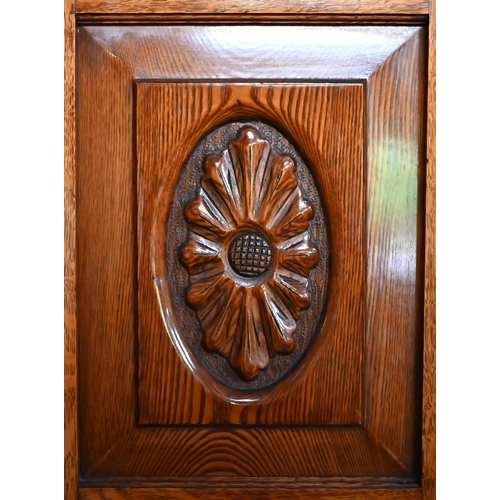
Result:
[179, 126, 319, 380]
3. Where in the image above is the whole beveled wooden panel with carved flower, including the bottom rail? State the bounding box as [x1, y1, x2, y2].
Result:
[76, 25, 426, 500]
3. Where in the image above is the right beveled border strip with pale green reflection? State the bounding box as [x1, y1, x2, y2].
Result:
[366, 30, 426, 473]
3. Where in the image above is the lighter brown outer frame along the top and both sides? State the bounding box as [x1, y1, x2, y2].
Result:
[64, 0, 436, 500]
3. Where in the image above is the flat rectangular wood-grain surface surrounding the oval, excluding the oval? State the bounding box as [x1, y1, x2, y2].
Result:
[137, 83, 365, 424]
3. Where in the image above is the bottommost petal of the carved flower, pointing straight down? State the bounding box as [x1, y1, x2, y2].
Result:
[229, 288, 269, 380]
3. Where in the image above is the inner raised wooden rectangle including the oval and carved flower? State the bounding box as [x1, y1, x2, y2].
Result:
[137, 83, 365, 424]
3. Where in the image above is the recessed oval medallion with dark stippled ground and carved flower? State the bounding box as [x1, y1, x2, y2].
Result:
[165, 122, 329, 390]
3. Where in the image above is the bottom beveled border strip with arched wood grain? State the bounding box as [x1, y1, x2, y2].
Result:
[85, 426, 408, 476]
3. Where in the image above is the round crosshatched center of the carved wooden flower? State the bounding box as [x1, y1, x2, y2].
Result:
[229, 233, 272, 276]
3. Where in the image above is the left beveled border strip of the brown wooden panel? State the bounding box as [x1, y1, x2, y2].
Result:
[77, 27, 136, 469]
